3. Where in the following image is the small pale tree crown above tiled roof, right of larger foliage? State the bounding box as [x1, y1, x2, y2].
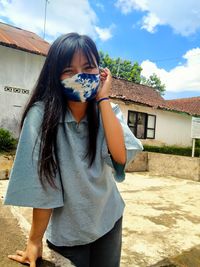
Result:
[141, 73, 165, 95]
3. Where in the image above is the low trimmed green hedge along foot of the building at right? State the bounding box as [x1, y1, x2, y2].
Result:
[143, 145, 200, 157]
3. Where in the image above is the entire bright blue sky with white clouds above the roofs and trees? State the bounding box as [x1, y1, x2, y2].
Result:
[0, 0, 200, 99]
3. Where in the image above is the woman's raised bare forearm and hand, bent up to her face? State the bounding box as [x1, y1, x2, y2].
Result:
[97, 69, 126, 165]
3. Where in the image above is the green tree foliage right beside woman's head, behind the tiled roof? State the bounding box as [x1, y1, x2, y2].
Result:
[99, 51, 142, 83]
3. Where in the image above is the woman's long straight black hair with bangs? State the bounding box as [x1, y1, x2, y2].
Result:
[21, 33, 100, 187]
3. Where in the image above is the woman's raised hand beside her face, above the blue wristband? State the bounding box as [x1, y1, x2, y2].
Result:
[96, 68, 112, 100]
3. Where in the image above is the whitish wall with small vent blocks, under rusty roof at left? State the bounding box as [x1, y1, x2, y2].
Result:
[0, 45, 45, 136]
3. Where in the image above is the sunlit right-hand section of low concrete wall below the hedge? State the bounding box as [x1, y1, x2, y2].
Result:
[148, 152, 200, 181]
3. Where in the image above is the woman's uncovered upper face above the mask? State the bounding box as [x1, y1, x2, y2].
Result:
[61, 50, 99, 81]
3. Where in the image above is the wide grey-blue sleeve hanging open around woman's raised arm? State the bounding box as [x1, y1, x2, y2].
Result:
[102, 103, 143, 182]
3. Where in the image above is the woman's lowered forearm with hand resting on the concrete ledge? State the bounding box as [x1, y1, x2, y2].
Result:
[8, 208, 52, 267]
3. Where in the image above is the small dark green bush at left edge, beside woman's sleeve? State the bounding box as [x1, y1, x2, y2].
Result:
[0, 128, 17, 152]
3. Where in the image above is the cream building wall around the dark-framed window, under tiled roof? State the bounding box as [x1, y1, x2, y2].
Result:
[113, 100, 192, 146]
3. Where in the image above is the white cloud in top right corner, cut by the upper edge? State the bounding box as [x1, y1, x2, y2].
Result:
[116, 0, 200, 36]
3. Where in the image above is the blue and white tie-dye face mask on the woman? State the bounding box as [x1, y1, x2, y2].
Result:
[61, 73, 100, 102]
